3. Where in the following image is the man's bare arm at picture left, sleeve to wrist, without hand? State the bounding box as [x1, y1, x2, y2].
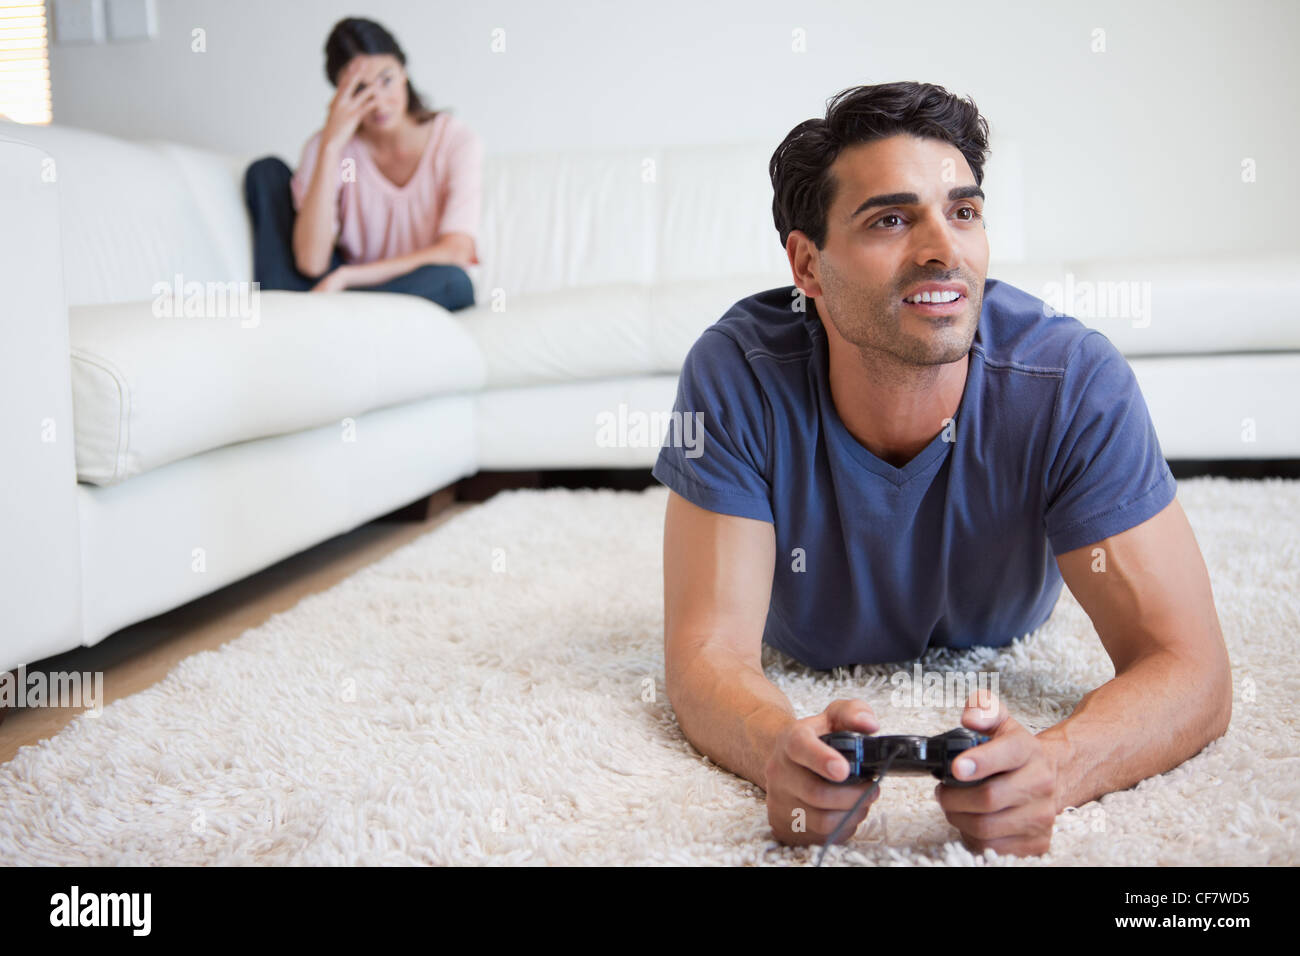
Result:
[663, 492, 794, 788]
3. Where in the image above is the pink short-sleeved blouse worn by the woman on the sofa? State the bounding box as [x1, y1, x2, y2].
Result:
[290, 113, 484, 264]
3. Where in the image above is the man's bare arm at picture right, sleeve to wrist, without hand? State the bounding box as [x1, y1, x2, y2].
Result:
[1037, 498, 1232, 813]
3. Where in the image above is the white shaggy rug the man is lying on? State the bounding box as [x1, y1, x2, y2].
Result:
[0, 479, 1300, 865]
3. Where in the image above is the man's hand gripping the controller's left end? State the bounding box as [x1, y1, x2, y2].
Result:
[766, 700, 880, 844]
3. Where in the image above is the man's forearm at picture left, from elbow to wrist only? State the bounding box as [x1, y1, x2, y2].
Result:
[668, 652, 796, 790]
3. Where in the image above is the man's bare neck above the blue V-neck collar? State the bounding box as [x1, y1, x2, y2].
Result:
[823, 324, 970, 468]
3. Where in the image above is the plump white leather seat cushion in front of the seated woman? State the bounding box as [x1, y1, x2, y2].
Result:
[69, 286, 484, 485]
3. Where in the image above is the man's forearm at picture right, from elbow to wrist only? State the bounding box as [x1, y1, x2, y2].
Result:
[1037, 652, 1232, 813]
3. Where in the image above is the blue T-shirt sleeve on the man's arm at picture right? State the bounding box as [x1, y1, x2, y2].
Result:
[1044, 330, 1178, 555]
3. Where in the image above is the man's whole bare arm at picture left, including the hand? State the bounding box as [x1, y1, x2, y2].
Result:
[663, 492, 880, 843]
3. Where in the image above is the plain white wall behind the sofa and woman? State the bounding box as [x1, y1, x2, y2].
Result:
[52, 0, 1300, 259]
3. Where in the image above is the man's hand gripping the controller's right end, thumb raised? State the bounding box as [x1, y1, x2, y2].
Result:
[935, 691, 1058, 856]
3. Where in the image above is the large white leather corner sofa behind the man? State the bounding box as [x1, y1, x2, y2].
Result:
[0, 121, 1300, 669]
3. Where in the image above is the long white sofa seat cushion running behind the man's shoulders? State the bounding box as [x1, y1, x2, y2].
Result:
[456, 256, 1300, 388]
